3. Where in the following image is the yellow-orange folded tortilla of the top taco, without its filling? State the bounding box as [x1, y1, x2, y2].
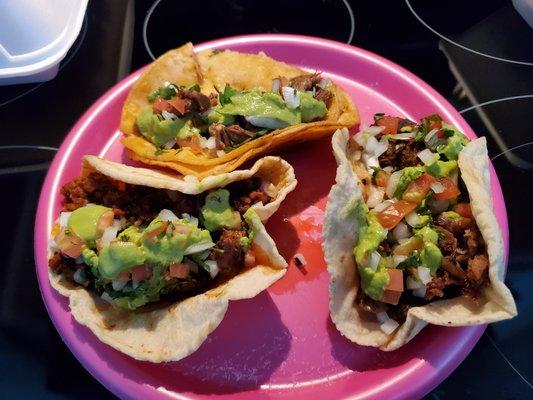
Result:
[120, 43, 359, 177]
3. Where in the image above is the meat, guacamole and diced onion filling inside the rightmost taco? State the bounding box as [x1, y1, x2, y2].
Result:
[350, 114, 489, 334]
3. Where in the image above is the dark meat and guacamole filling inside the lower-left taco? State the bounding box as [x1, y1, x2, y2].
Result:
[49, 172, 275, 310]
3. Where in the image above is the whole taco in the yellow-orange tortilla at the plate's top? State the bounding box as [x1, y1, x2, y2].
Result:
[120, 43, 359, 177]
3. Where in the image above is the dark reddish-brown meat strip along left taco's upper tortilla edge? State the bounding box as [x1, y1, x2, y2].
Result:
[61, 172, 199, 225]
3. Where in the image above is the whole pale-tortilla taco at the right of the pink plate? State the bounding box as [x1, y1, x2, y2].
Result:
[323, 114, 517, 351]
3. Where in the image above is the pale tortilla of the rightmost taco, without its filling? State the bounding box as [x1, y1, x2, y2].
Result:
[323, 129, 517, 351]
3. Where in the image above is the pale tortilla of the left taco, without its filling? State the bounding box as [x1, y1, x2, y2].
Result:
[49, 156, 296, 363]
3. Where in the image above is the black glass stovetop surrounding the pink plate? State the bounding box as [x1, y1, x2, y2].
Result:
[0, 0, 533, 399]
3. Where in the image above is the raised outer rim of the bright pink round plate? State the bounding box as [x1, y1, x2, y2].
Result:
[34, 34, 509, 398]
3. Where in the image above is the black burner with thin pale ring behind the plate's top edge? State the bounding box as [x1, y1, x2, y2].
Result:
[143, 0, 355, 60]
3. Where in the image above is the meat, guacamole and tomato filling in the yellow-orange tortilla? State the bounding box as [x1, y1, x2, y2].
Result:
[136, 73, 334, 158]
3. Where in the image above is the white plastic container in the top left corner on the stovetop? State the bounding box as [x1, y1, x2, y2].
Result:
[0, 0, 88, 86]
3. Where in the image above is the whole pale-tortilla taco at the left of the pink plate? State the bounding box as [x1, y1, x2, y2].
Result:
[49, 156, 296, 362]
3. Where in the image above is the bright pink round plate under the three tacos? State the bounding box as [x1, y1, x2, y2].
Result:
[35, 35, 508, 399]
